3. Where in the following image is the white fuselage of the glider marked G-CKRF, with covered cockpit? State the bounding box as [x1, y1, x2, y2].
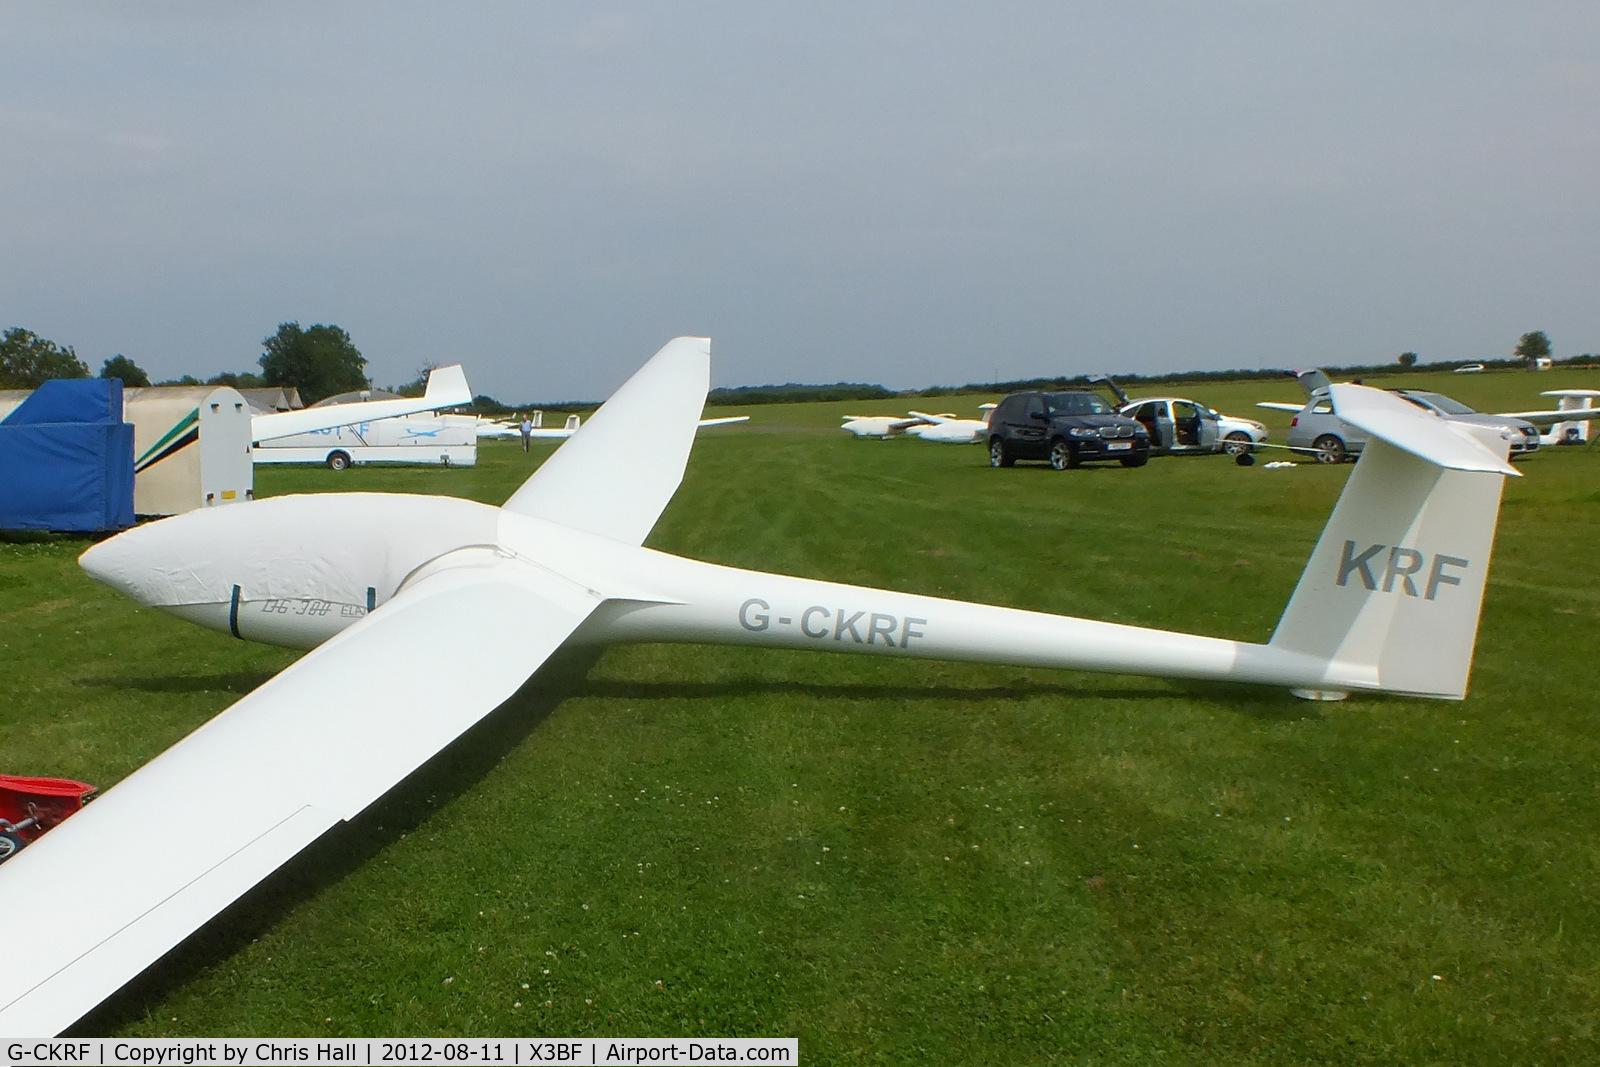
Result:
[83, 493, 1350, 688]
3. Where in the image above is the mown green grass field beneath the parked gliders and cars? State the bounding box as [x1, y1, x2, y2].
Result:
[9, 371, 1600, 1064]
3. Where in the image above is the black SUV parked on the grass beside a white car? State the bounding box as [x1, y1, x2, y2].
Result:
[989, 392, 1150, 470]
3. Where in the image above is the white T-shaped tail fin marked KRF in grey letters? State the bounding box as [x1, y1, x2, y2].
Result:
[1272, 386, 1517, 699]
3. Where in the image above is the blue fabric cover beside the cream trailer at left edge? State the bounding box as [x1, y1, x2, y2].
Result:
[0, 378, 133, 533]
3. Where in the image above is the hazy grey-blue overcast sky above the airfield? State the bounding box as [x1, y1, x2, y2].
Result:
[0, 0, 1600, 402]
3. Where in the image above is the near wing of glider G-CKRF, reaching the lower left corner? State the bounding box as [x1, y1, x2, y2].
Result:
[0, 549, 598, 1037]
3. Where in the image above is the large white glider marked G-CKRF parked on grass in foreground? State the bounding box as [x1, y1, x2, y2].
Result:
[0, 338, 1517, 1037]
